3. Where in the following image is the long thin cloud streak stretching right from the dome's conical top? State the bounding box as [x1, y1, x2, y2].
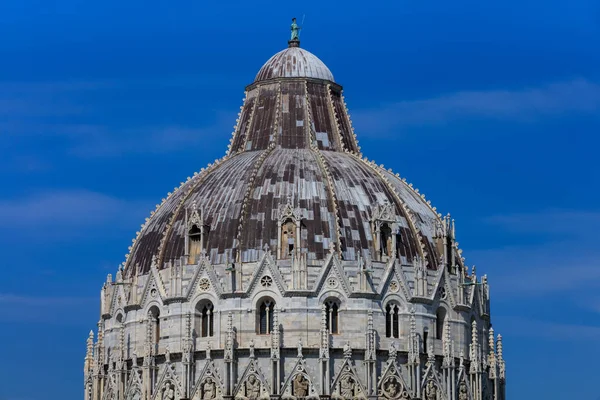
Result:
[352, 79, 600, 135]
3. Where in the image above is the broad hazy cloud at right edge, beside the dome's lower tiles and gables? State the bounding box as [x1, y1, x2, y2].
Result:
[469, 210, 600, 298]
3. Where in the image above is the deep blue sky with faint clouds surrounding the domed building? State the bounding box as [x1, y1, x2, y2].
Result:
[0, 0, 600, 400]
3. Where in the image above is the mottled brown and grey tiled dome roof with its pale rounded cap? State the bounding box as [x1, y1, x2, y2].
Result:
[125, 42, 450, 275]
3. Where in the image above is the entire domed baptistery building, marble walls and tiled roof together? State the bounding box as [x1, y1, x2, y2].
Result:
[85, 30, 505, 400]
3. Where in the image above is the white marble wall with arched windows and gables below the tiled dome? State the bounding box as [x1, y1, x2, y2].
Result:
[85, 245, 505, 400]
